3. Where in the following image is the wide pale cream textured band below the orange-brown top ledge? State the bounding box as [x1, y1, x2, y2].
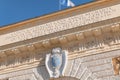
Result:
[0, 4, 120, 46]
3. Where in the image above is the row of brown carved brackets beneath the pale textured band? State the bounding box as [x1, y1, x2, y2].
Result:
[0, 23, 120, 57]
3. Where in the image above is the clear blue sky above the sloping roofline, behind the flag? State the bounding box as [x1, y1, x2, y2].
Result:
[0, 0, 93, 26]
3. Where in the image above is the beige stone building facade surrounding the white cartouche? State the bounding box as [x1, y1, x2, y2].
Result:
[0, 0, 120, 80]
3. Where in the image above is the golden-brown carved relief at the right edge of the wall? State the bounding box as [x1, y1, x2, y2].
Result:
[112, 57, 120, 75]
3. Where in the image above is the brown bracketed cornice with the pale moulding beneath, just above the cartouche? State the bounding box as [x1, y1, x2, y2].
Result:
[0, 23, 120, 72]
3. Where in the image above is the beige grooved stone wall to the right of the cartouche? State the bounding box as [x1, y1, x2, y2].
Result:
[65, 50, 120, 80]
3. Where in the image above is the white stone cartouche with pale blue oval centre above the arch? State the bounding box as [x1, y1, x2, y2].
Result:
[45, 47, 68, 78]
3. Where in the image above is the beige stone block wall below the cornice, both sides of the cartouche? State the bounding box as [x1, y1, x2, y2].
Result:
[0, 50, 120, 80]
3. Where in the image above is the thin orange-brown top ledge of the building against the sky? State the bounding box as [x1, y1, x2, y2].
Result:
[0, 0, 115, 32]
